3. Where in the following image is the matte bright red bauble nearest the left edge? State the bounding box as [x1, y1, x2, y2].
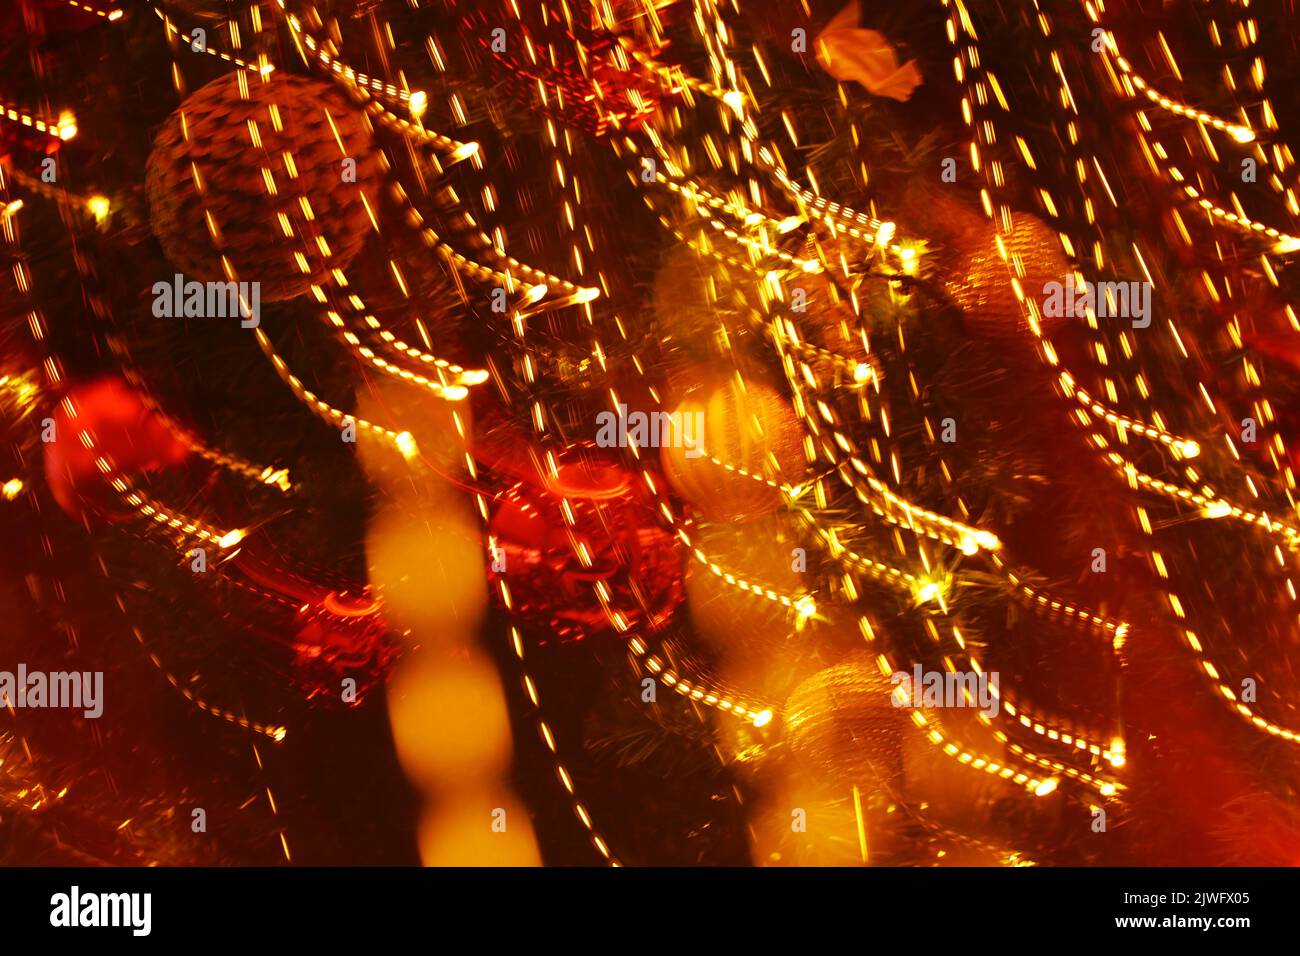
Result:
[42, 376, 190, 519]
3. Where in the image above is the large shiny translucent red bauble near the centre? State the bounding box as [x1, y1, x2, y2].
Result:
[489, 475, 684, 640]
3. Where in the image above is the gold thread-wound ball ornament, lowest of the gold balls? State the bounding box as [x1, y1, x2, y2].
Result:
[785, 653, 910, 787]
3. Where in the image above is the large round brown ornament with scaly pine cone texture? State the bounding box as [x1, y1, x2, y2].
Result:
[144, 73, 384, 300]
